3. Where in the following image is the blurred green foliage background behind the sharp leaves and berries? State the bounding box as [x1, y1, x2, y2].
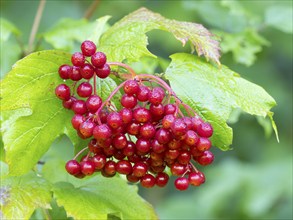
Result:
[1, 0, 293, 219]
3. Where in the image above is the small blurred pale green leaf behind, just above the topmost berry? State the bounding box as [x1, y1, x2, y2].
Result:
[43, 16, 110, 50]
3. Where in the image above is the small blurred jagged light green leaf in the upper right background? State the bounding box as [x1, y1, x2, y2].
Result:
[214, 28, 270, 66]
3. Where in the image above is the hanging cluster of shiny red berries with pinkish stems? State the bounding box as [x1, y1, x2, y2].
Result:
[55, 41, 214, 190]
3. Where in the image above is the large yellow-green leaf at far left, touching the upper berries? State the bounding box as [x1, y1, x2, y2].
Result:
[1, 51, 76, 175]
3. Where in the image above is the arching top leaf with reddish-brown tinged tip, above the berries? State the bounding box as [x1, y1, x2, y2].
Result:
[99, 8, 220, 63]
